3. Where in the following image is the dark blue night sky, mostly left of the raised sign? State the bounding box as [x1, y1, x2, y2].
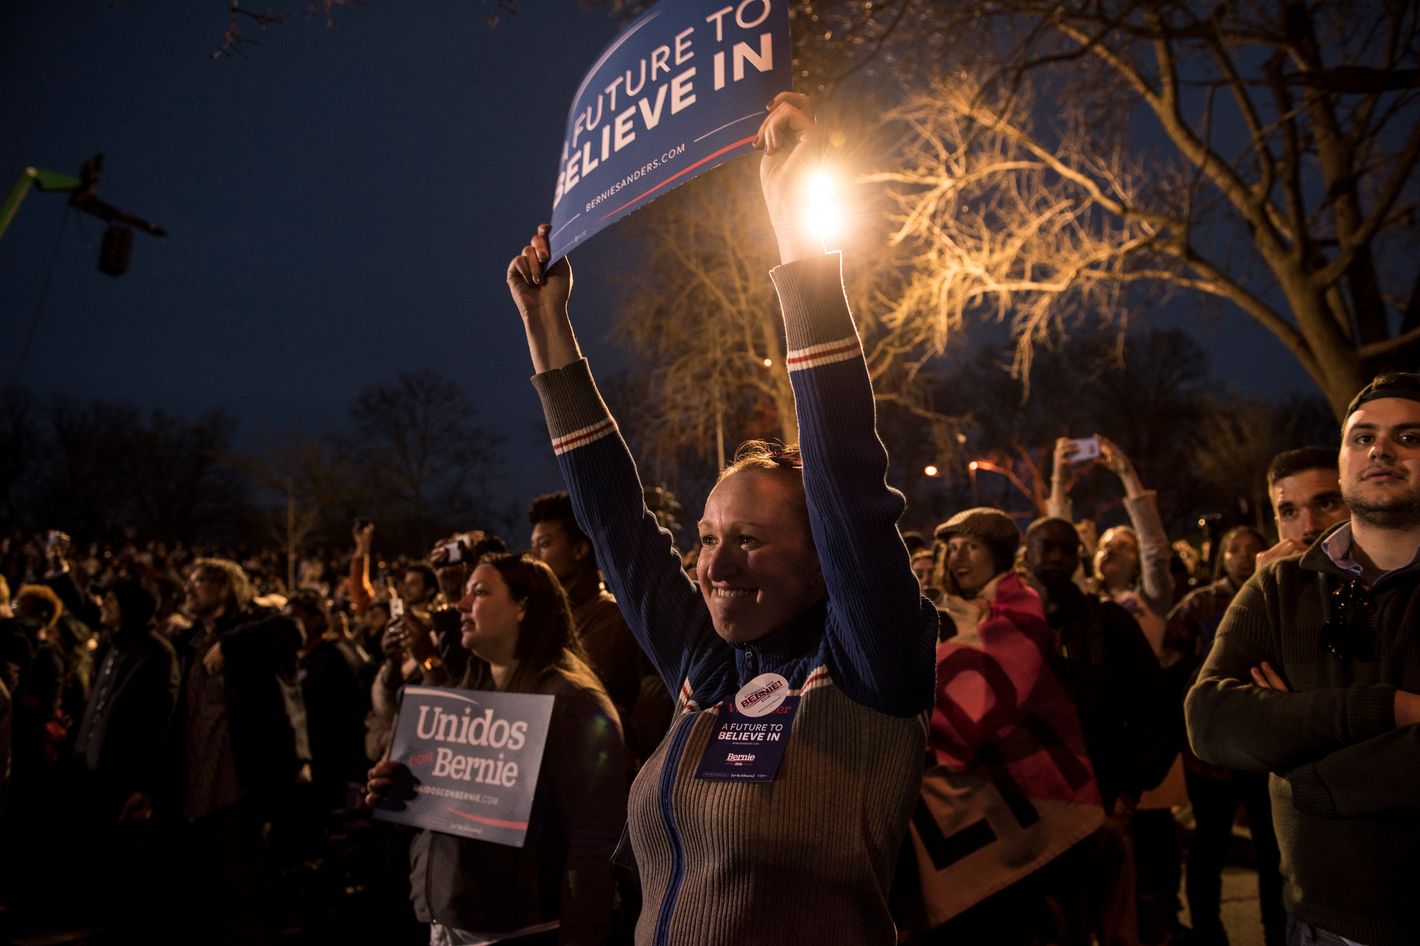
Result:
[0, 0, 1308, 517]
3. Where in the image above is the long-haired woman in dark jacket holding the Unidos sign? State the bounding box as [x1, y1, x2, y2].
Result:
[368, 554, 626, 946]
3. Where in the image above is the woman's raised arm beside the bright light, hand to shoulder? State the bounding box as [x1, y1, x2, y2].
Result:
[755, 92, 937, 716]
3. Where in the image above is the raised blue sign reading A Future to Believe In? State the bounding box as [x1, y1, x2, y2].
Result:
[551, 0, 792, 261]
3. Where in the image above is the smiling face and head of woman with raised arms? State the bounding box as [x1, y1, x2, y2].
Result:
[697, 470, 826, 642]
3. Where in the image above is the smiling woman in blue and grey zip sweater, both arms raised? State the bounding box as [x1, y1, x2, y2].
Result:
[507, 94, 937, 946]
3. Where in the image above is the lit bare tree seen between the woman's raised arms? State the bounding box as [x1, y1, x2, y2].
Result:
[615, 162, 798, 482]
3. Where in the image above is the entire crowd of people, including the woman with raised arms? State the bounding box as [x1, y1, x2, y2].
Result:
[0, 94, 1420, 946]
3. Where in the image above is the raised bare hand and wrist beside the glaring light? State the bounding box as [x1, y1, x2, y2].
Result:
[754, 92, 824, 263]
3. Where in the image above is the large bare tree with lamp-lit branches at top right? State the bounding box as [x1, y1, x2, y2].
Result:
[873, 0, 1420, 412]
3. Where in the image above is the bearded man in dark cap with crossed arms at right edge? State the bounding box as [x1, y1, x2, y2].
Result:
[1186, 372, 1420, 946]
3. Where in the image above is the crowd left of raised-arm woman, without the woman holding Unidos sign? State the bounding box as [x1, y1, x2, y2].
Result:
[0, 493, 670, 943]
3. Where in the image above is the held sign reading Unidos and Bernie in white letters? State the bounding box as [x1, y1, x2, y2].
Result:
[375, 686, 554, 848]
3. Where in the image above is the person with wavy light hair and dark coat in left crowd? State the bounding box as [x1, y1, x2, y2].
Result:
[168, 558, 311, 943]
